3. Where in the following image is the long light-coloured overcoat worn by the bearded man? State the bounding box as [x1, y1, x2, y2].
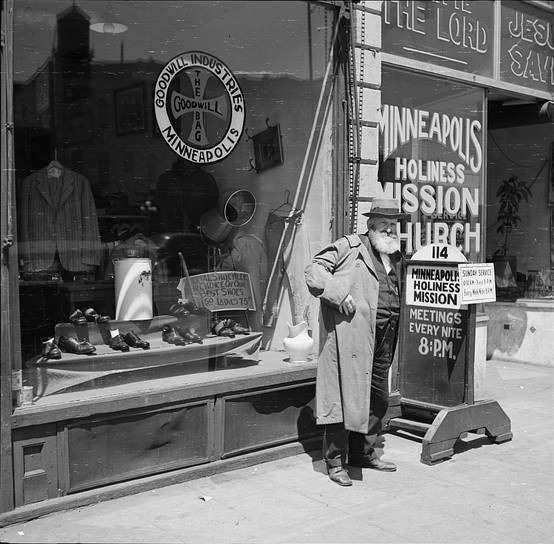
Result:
[305, 234, 379, 434]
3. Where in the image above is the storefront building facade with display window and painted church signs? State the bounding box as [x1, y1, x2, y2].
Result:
[0, 0, 554, 520]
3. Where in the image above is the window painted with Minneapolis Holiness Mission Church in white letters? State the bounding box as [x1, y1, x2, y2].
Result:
[379, 68, 480, 262]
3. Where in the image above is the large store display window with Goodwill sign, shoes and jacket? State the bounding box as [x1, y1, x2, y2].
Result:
[13, 0, 338, 395]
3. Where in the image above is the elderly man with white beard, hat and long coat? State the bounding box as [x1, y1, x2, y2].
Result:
[305, 199, 408, 486]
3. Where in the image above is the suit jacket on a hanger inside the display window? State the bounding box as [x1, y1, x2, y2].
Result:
[19, 168, 101, 272]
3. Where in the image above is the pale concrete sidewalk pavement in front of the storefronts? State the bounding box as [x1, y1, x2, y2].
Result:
[0, 360, 554, 544]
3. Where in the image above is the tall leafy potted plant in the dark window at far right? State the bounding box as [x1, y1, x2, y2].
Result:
[493, 175, 532, 279]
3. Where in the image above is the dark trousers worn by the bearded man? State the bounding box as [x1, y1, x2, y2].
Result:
[323, 319, 397, 468]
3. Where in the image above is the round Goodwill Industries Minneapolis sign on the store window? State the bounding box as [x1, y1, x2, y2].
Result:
[154, 51, 245, 164]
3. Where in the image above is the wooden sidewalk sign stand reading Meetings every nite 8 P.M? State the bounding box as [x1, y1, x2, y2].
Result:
[384, 245, 512, 465]
